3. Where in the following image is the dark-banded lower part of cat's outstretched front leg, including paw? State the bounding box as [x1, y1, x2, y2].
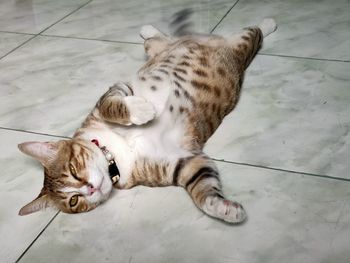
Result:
[173, 155, 246, 223]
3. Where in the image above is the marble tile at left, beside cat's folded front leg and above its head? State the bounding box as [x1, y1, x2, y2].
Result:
[0, 37, 144, 136]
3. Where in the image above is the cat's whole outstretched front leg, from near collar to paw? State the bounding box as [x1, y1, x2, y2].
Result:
[116, 155, 246, 223]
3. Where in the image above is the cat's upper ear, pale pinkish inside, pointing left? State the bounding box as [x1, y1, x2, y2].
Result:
[18, 142, 58, 165]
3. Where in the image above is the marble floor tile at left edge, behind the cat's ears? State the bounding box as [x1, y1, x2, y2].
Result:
[0, 129, 56, 262]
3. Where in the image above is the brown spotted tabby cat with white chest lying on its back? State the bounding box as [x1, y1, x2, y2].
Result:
[18, 19, 276, 223]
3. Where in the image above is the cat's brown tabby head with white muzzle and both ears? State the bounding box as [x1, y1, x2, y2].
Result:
[18, 139, 112, 215]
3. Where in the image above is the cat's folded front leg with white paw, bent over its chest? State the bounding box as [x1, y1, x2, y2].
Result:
[93, 82, 156, 125]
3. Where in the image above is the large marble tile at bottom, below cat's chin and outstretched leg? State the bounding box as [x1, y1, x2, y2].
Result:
[18, 163, 350, 263]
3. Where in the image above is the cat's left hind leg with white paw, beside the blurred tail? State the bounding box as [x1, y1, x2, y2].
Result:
[140, 25, 170, 58]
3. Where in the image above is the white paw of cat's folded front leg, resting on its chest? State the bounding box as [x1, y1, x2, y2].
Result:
[124, 96, 156, 125]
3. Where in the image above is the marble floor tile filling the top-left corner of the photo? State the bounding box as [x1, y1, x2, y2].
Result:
[0, 0, 88, 33]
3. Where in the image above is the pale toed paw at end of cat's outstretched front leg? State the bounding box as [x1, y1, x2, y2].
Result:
[203, 196, 247, 224]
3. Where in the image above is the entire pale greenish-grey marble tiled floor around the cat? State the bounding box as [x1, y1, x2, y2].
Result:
[0, 0, 350, 263]
